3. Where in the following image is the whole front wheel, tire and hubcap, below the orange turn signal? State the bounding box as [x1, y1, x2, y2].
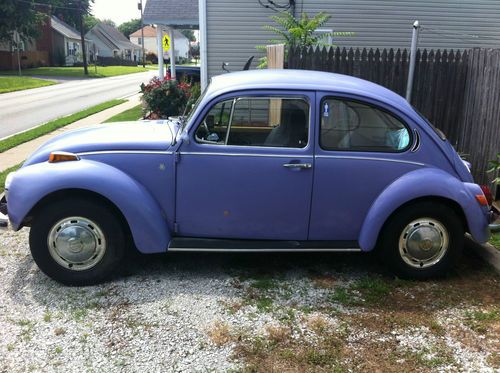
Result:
[30, 199, 125, 286]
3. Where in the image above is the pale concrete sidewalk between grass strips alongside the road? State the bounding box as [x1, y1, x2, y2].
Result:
[0, 94, 141, 172]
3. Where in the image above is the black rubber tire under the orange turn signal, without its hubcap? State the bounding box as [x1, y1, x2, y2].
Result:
[29, 199, 126, 286]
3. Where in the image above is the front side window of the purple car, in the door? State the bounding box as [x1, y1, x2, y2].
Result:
[195, 97, 309, 148]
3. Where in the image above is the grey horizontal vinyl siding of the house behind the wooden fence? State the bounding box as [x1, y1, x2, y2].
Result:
[206, 0, 500, 77]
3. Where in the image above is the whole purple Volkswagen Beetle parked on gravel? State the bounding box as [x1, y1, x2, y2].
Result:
[3, 70, 496, 285]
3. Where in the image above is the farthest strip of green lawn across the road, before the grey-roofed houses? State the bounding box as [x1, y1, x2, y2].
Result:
[2, 66, 149, 78]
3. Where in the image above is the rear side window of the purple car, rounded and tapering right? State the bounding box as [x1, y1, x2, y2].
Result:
[319, 98, 410, 152]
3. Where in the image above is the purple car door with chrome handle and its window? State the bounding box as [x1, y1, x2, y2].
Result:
[176, 91, 315, 240]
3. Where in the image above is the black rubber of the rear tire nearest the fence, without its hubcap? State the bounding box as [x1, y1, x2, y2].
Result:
[378, 201, 465, 280]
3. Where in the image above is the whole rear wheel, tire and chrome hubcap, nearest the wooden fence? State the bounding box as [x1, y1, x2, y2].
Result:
[379, 202, 464, 279]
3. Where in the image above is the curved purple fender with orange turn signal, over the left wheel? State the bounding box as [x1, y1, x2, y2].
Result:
[7, 160, 171, 253]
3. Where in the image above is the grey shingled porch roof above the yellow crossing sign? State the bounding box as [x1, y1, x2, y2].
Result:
[144, 0, 199, 28]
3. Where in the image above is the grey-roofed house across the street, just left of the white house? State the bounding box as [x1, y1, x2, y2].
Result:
[85, 22, 141, 61]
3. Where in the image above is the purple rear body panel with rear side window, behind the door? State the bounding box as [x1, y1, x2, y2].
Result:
[309, 92, 423, 241]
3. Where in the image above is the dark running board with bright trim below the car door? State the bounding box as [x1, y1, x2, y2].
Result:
[168, 237, 361, 253]
